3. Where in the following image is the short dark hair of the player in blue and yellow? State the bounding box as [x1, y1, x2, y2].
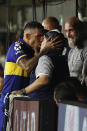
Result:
[24, 21, 44, 30]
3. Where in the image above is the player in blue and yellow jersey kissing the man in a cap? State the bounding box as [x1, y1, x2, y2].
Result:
[0, 22, 60, 131]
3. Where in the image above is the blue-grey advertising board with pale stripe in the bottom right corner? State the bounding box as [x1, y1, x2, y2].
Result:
[58, 101, 87, 131]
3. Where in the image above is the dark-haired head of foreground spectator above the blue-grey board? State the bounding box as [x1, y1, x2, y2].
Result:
[54, 81, 77, 105]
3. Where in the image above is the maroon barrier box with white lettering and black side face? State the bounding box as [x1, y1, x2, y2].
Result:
[7, 97, 58, 131]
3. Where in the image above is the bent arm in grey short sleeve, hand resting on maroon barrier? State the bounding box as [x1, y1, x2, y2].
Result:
[12, 53, 54, 94]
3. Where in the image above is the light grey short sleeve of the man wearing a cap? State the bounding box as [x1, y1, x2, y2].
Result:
[35, 55, 54, 78]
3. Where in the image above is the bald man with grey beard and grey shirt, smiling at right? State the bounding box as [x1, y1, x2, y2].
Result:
[65, 17, 87, 80]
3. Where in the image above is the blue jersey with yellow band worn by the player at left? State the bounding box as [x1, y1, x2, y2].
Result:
[2, 39, 34, 95]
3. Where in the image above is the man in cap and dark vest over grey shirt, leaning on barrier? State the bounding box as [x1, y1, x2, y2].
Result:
[12, 30, 69, 99]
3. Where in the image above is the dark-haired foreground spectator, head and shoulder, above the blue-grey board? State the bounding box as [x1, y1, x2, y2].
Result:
[54, 77, 87, 104]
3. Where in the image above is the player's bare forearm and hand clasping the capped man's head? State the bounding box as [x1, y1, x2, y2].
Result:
[18, 37, 62, 73]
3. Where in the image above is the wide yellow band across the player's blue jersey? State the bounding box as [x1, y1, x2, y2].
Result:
[5, 62, 28, 77]
